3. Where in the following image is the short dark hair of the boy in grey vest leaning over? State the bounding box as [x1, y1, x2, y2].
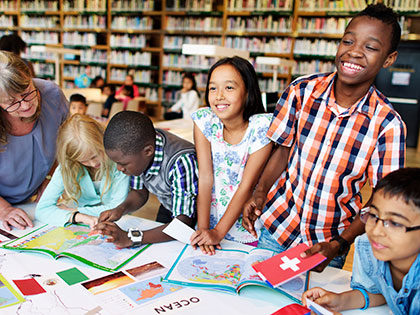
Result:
[104, 110, 156, 155]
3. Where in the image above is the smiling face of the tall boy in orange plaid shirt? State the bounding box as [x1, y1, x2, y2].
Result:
[335, 16, 397, 93]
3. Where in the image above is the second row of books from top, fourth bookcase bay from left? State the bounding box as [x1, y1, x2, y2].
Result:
[166, 17, 223, 32]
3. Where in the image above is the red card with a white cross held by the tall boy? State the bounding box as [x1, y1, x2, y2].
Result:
[252, 243, 327, 287]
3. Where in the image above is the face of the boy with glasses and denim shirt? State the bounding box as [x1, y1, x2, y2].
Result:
[366, 191, 420, 271]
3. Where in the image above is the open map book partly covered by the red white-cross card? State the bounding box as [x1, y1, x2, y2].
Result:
[163, 245, 309, 303]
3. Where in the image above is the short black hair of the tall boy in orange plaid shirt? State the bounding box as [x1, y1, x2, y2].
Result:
[353, 3, 401, 53]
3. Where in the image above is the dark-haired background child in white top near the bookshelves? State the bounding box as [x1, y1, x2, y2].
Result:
[163, 72, 200, 120]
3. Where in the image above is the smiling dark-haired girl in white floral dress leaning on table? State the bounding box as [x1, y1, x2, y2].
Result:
[191, 57, 272, 254]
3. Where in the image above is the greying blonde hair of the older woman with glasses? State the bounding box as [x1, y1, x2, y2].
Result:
[0, 51, 41, 145]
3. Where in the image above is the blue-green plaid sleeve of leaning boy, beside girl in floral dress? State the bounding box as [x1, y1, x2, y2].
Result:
[169, 153, 198, 217]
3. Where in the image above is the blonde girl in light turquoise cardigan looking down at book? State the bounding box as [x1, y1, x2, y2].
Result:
[35, 114, 129, 227]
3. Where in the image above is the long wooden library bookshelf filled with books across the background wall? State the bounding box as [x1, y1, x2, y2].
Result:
[4, 0, 420, 116]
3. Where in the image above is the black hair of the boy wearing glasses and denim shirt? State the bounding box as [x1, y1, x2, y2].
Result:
[373, 167, 420, 212]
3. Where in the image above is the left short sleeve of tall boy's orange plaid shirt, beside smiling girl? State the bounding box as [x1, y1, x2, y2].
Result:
[267, 84, 300, 147]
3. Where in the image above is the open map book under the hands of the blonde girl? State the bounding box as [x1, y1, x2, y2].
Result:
[2, 224, 149, 272]
